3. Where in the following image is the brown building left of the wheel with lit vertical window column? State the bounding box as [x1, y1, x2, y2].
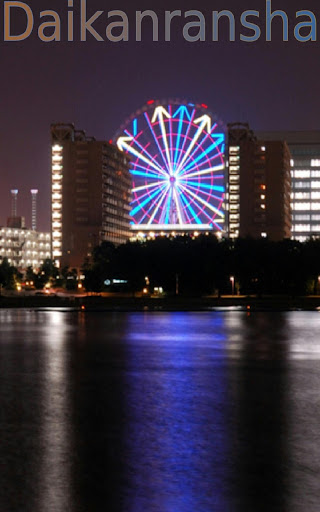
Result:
[51, 124, 131, 268]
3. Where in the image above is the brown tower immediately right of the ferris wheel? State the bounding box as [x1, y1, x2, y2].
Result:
[226, 123, 292, 240]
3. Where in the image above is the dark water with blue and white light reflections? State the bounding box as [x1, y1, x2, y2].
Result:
[0, 311, 320, 512]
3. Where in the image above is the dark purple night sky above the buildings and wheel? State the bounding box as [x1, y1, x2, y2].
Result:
[0, 0, 320, 230]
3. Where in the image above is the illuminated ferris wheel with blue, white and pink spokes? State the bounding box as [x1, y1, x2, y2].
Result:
[117, 101, 225, 231]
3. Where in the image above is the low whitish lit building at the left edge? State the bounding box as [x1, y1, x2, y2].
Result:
[0, 227, 51, 270]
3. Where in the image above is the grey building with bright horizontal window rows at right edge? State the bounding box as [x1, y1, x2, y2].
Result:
[260, 131, 320, 242]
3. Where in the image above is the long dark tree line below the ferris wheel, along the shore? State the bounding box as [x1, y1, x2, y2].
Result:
[83, 236, 320, 295]
